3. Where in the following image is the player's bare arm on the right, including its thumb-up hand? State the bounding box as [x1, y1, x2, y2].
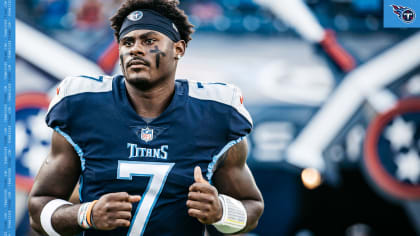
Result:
[187, 140, 264, 233]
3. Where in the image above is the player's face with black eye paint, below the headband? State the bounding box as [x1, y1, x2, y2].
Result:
[119, 30, 185, 89]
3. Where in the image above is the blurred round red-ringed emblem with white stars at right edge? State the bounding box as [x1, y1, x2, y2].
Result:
[364, 99, 420, 200]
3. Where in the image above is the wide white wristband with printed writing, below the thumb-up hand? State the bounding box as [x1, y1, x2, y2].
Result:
[213, 194, 247, 234]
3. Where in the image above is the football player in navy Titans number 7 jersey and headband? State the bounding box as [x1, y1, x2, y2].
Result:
[29, 0, 264, 236]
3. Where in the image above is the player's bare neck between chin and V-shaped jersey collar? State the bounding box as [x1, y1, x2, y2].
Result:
[125, 79, 175, 118]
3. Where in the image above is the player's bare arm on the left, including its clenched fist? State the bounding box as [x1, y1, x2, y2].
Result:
[28, 132, 140, 235]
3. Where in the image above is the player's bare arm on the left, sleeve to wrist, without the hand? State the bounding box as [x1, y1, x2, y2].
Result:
[28, 132, 81, 235]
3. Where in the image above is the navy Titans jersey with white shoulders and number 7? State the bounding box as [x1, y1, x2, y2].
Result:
[46, 76, 252, 236]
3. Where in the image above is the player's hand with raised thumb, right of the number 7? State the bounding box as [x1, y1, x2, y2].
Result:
[187, 166, 223, 224]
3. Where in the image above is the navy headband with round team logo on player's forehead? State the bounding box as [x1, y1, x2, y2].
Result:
[119, 9, 181, 42]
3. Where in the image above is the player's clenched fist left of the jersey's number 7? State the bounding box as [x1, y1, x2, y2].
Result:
[92, 192, 141, 230]
